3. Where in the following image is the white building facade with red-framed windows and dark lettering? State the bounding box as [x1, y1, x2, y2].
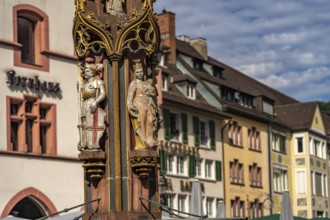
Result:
[0, 0, 84, 218]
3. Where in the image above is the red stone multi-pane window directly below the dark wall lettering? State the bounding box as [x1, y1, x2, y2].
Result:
[7, 96, 56, 155]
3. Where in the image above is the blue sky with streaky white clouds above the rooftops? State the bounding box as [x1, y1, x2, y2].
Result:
[154, 0, 330, 102]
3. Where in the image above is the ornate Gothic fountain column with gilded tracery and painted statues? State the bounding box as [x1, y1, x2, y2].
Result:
[73, 0, 160, 219]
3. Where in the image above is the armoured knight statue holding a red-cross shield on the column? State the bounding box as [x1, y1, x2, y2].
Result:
[78, 58, 106, 151]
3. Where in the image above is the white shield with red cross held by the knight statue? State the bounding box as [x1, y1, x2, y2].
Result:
[85, 108, 105, 149]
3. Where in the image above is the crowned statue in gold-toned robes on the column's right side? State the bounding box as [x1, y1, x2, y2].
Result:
[127, 63, 159, 150]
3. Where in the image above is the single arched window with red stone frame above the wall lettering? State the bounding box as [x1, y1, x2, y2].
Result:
[14, 4, 49, 71]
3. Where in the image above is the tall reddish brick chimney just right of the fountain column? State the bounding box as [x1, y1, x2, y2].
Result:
[158, 10, 176, 64]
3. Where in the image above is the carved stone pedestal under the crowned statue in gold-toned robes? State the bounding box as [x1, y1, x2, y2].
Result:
[128, 150, 158, 178]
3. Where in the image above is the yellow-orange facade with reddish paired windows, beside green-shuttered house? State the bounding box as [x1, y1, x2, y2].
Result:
[223, 116, 271, 218]
